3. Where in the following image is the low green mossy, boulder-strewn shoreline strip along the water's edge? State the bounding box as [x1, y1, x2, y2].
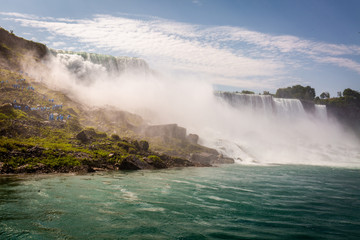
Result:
[0, 128, 233, 174]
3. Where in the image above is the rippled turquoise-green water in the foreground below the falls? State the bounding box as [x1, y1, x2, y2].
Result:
[0, 165, 360, 239]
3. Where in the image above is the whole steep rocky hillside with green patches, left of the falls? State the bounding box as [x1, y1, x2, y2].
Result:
[0, 29, 233, 173]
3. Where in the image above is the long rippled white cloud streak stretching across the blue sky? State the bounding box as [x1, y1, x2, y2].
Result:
[0, 12, 360, 88]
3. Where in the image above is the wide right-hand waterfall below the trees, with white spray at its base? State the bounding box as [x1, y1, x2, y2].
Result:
[205, 92, 360, 167]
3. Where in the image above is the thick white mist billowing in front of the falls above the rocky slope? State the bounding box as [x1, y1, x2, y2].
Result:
[23, 50, 360, 167]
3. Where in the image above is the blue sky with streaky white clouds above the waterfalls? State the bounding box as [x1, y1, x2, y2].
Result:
[0, 0, 360, 95]
